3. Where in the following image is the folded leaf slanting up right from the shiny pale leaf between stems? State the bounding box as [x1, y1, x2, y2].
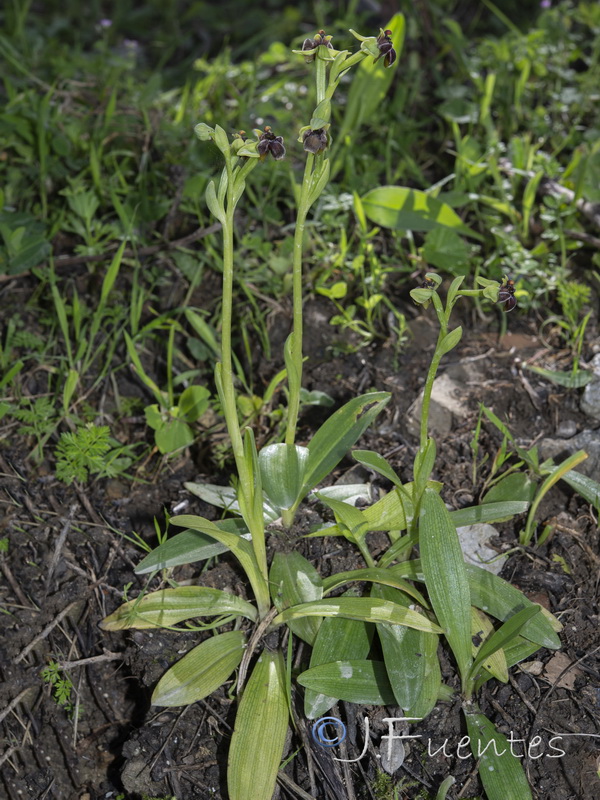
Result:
[303, 392, 391, 494]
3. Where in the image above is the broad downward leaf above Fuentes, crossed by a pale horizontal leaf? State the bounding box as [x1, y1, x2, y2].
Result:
[371, 584, 428, 708]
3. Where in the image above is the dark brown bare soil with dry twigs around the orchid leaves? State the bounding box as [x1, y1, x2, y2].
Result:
[0, 286, 600, 800]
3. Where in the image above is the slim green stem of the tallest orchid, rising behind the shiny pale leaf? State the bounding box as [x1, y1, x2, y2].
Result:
[285, 153, 315, 444]
